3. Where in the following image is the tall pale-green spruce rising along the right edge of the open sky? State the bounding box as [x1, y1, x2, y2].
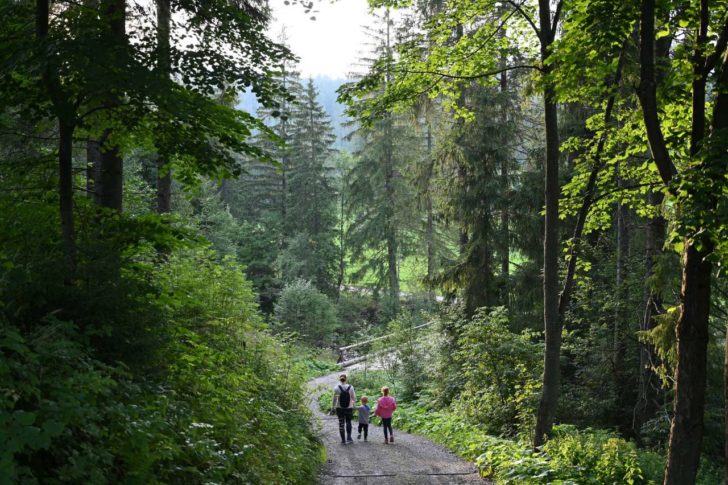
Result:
[343, 10, 421, 313]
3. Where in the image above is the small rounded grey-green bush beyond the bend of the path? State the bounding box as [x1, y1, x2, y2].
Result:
[275, 280, 338, 346]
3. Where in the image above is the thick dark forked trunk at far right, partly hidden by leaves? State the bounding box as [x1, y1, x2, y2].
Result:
[639, 0, 720, 485]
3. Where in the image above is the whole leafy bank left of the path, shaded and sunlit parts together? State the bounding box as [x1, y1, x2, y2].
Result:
[0, 236, 320, 484]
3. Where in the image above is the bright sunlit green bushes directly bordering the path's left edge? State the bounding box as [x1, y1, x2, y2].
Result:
[151, 252, 319, 483]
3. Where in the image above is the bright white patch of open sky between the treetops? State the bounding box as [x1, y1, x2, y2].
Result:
[269, 0, 378, 79]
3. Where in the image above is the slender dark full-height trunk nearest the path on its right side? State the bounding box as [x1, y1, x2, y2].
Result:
[534, 0, 561, 442]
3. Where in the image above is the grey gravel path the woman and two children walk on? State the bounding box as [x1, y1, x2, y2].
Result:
[308, 372, 489, 485]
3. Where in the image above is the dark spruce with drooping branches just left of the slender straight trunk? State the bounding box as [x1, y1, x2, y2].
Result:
[435, 85, 517, 315]
